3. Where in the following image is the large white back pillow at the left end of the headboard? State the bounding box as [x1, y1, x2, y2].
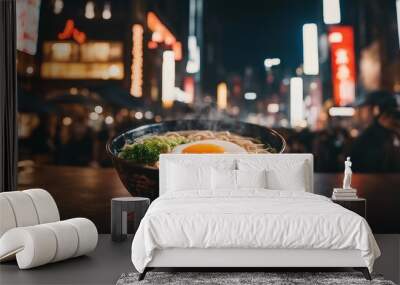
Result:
[167, 163, 212, 191]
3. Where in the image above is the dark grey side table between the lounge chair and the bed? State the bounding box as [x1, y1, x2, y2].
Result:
[111, 197, 150, 241]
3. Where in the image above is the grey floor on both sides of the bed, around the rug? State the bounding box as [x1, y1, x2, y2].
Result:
[0, 235, 400, 285]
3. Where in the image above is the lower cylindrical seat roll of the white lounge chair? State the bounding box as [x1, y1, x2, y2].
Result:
[0, 218, 98, 269]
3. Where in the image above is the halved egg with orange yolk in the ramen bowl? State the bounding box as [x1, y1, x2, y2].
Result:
[172, 140, 247, 153]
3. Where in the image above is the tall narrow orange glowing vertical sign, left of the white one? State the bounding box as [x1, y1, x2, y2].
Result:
[130, 24, 143, 97]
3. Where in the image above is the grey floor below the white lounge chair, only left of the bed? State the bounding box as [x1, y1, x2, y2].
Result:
[0, 235, 135, 285]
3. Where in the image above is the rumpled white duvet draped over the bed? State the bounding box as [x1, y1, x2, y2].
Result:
[132, 189, 380, 272]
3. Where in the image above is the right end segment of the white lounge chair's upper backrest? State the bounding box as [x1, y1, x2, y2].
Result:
[22, 188, 60, 224]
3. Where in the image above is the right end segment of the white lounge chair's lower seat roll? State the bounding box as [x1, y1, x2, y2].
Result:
[64, 218, 98, 257]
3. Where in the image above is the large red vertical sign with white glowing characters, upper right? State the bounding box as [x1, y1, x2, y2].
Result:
[328, 26, 356, 106]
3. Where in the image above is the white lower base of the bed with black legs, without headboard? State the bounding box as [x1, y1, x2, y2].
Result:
[139, 248, 371, 281]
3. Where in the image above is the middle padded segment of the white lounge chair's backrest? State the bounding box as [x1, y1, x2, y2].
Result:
[0, 191, 39, 227]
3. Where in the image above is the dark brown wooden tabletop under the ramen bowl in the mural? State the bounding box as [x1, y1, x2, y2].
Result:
[18, 166, 400, 234]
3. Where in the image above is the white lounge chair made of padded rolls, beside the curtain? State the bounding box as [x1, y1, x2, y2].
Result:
[0, 189, 98, 269]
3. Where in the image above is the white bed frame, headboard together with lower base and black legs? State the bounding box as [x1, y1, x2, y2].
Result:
[139, 154, 371, 280]
